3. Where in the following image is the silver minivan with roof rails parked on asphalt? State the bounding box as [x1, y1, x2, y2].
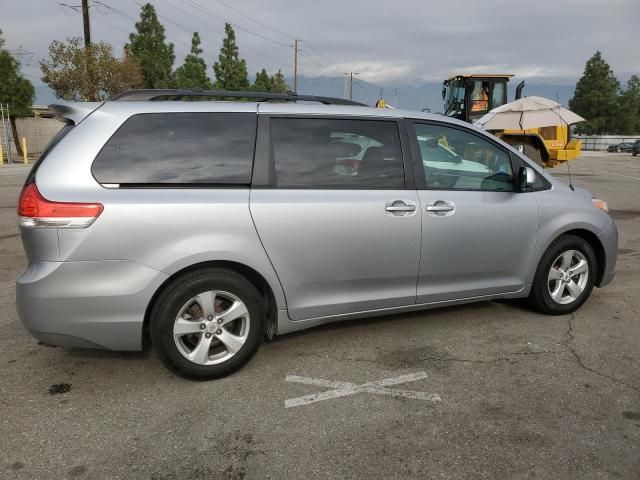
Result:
[16, 91, 618, 378]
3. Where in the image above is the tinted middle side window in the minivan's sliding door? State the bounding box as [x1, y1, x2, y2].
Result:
[271, 118, 404, 189]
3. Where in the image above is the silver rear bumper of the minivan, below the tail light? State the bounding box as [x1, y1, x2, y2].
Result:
[16, 260, 167, 350]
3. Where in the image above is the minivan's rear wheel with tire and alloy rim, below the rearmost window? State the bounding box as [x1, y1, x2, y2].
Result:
[150, 268, 265, 380]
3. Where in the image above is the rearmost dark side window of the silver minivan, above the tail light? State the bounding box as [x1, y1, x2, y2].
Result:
[92, 113, 257, 185]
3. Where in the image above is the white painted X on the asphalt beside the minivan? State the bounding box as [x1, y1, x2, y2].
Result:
[284, 372, 441, 408]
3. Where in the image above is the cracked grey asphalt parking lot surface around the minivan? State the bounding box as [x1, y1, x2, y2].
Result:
[0, 153, 640, 480]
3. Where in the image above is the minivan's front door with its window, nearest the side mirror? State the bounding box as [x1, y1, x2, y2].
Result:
[411, 123, 538, 303]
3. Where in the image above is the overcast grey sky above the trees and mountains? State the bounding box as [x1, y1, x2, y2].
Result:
[0, 0, 640, 95]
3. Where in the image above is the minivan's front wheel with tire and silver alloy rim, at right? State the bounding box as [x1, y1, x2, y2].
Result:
[529, 235, 597, 315]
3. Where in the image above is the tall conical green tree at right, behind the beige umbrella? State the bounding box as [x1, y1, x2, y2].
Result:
[569, 52, 620, 135]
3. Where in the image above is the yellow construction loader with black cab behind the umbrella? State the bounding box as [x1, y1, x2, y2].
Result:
[442, 74, 582, 168]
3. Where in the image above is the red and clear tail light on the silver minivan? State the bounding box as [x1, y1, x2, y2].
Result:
[18, 182, 104, 228]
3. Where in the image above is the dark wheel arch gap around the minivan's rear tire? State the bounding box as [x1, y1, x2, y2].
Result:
[142, 260, 278, 350]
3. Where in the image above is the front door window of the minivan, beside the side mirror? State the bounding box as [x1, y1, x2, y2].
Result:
[415, 124, 514, 191]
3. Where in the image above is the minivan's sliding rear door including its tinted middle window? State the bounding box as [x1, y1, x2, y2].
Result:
[250, 117, 421, 320]
